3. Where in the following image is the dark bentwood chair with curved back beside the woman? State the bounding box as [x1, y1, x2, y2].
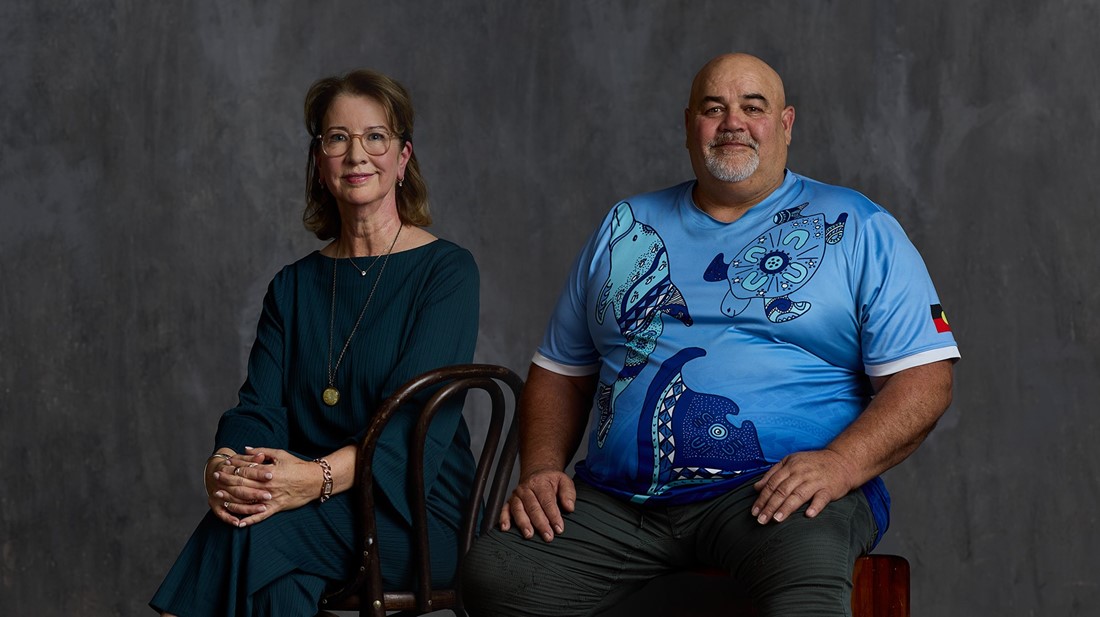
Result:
[320, 364, 524, 617]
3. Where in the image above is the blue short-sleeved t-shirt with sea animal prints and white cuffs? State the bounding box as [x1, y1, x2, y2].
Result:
[535, 172, 959, 541]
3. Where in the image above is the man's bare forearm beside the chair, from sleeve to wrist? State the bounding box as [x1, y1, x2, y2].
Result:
[519, 364, 598, 477]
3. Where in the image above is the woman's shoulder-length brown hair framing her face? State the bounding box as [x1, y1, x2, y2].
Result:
[301, 69, 431, 240]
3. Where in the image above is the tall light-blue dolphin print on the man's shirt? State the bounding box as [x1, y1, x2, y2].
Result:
[596, 201, 692, 448]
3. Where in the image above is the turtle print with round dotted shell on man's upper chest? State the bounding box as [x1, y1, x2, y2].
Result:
[703, 201, 848, 323]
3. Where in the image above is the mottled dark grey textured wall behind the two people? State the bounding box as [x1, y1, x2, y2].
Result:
[0, 0, 1100, 617]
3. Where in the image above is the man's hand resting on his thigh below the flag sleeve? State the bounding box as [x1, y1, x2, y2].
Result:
[752, 450, 858, 525]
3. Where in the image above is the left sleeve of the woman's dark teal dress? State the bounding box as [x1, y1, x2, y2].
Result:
[215, 271, 288, 453]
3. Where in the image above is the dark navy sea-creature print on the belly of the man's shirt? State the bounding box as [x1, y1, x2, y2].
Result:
[638, 348, 767, 495]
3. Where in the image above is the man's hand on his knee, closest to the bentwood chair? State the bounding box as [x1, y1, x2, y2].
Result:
[501, 470, 576, 542]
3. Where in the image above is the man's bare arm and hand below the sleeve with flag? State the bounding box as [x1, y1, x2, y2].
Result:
[752, 360, 954, 524]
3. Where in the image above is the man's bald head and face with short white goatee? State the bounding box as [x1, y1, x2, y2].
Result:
[684, 56, 794, 190]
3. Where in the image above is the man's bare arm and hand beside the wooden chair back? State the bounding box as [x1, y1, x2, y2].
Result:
[501, 364, 598, 542]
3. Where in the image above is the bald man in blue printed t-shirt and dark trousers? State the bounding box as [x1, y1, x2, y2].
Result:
[463, 54, 959, 617]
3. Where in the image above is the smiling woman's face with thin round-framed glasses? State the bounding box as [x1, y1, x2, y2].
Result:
[316, 95, 413, 213]
